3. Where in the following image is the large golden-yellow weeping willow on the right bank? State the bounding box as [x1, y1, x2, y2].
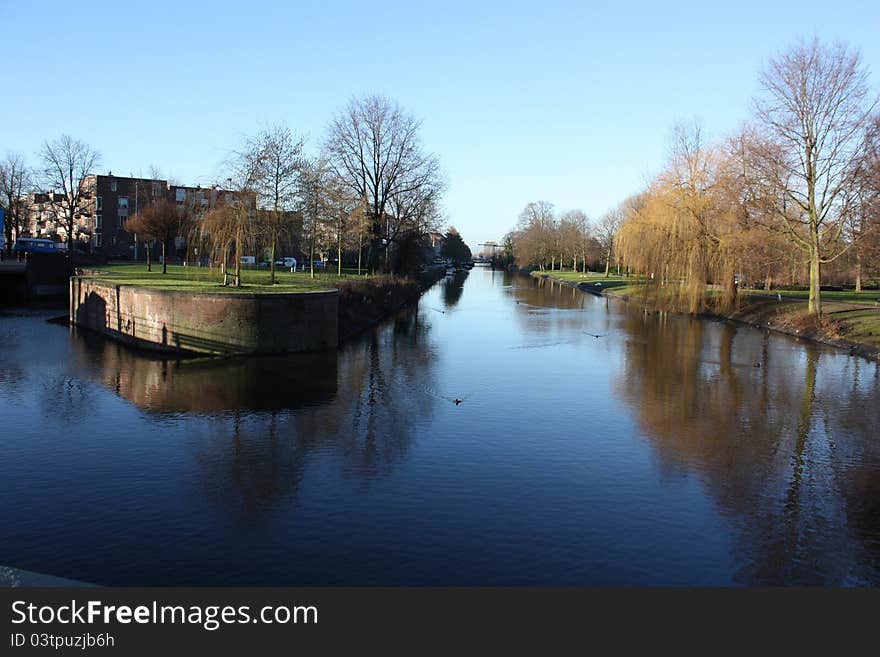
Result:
[617, 125, 742, 313]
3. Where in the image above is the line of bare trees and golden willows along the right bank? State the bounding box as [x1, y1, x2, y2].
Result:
[502, 39, 880, 315]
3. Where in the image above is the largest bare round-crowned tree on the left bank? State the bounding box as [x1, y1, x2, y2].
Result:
[326, 96, 436, 271]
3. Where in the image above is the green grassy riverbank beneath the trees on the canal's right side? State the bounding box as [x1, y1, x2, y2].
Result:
[532, 271, 880, 359]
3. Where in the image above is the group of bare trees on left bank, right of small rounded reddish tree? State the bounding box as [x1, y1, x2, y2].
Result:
[179, 96, 444, 284]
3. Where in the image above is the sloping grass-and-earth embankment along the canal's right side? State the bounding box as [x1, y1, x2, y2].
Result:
[531, 271, 880, 361]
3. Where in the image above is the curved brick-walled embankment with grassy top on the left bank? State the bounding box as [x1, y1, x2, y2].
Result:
[69, 262, 442, 356]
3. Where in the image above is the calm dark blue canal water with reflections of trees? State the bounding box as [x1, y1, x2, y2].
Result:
[0, 267, 880, 585]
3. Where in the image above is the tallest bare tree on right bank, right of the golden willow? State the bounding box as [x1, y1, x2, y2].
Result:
[752, 39, 877, 315]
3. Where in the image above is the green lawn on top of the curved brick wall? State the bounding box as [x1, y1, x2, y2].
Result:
[77, 264, 364, 294]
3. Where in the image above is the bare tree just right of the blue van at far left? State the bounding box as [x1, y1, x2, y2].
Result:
[40, 135, 101, 257]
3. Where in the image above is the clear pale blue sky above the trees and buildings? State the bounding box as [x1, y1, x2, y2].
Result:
[0, 0, 880, 251]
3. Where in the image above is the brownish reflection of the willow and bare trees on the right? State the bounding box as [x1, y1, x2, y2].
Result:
[616, 312, 880, 584]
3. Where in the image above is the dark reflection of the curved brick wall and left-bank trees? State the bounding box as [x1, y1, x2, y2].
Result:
[78, 310, 436, 522]
